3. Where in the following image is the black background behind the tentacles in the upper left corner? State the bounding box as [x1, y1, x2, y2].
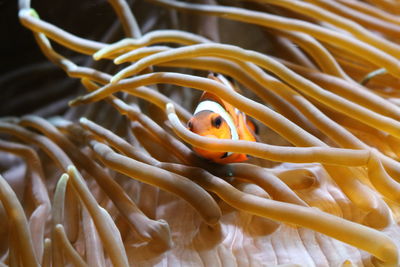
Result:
[0, 0, 150, 116]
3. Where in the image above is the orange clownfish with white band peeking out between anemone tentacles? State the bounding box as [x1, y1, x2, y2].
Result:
[187, 74, 257, 164]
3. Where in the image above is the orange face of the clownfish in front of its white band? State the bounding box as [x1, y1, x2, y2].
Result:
[187, 111, 232, 160]
